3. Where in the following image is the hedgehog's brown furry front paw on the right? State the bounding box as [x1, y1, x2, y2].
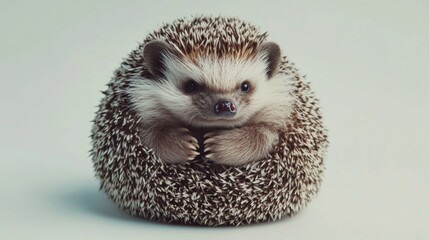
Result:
[204, 129, 275, 166]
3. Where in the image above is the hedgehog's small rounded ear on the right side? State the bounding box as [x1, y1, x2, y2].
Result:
[258, 42, 281, 78]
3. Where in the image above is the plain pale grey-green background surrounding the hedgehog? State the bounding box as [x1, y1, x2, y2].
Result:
[0, 0, 429, 240]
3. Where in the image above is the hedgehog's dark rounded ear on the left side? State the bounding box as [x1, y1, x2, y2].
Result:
[143, 40, 179, 78]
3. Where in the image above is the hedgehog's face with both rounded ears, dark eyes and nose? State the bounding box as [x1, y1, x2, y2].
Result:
[140, 41, 280, 127]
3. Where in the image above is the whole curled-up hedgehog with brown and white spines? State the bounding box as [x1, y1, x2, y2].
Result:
[91, 17, 328, 226]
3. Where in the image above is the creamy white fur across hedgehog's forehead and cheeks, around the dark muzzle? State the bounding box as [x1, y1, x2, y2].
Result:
[129, 55, 292, 127]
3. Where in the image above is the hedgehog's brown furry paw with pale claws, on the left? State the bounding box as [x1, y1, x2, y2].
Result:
[154, 128, 200, 163]
